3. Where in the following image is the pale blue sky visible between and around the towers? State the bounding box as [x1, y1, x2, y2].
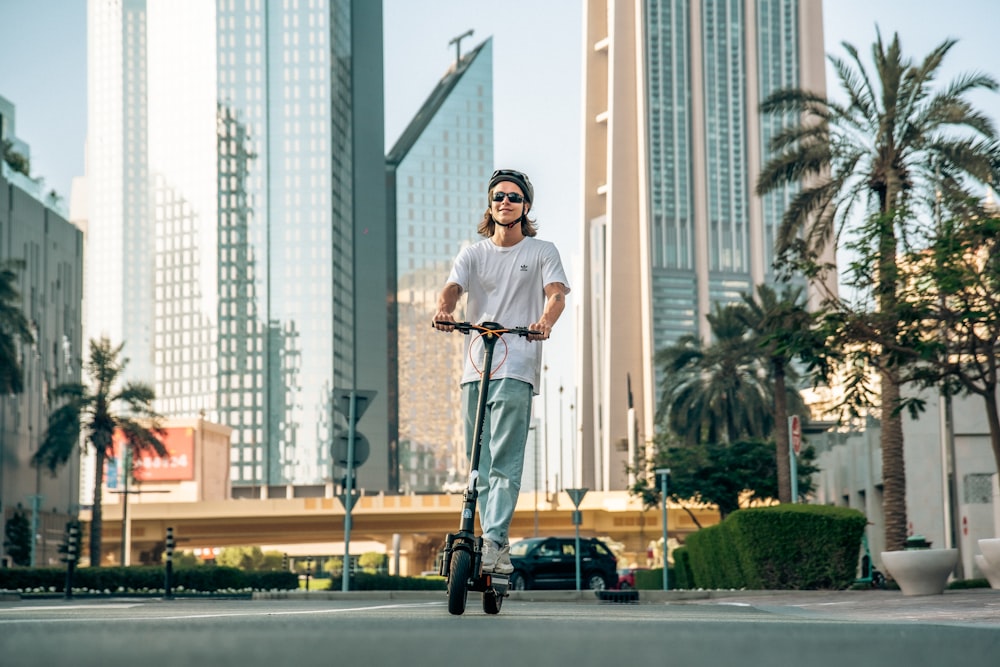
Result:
[0, 0, 1000, 488]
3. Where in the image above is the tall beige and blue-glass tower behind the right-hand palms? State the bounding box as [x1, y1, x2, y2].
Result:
[578, 0, 826, 489]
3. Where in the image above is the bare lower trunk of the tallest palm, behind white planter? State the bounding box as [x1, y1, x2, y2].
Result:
[880, 368, 907, 551]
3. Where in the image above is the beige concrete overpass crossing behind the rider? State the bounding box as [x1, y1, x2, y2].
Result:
[90, 491, 719, 575]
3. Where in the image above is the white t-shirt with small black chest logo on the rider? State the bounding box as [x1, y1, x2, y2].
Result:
[448, 236, 569, 394]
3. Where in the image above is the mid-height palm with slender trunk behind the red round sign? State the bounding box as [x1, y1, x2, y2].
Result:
[737, 285, 820, 503]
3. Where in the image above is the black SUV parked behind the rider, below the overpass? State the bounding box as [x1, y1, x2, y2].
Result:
[510, 537, 618, 591]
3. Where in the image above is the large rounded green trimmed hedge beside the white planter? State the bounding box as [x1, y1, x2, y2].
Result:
[675, 504, 867, 590]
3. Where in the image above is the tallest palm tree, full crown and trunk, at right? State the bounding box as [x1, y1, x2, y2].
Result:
[757, 33, 997, 550]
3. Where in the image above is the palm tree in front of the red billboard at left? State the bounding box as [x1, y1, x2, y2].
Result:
[32, 337, 167, 567]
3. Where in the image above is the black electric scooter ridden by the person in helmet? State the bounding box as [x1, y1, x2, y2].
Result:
[438, 322, 541, 615]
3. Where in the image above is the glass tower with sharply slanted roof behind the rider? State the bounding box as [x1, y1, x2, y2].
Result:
[386, 39, 493, 491]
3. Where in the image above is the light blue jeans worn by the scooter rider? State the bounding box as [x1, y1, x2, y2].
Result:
[462, 378, 532, 544]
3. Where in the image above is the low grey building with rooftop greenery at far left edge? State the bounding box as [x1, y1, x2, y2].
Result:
[0, 97, 83, 567]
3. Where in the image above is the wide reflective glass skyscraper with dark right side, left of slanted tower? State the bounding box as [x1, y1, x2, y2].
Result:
[88, 0, 391, 497]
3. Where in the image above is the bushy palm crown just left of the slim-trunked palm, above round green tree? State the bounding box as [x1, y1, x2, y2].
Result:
[656, 303, 773, 445]
